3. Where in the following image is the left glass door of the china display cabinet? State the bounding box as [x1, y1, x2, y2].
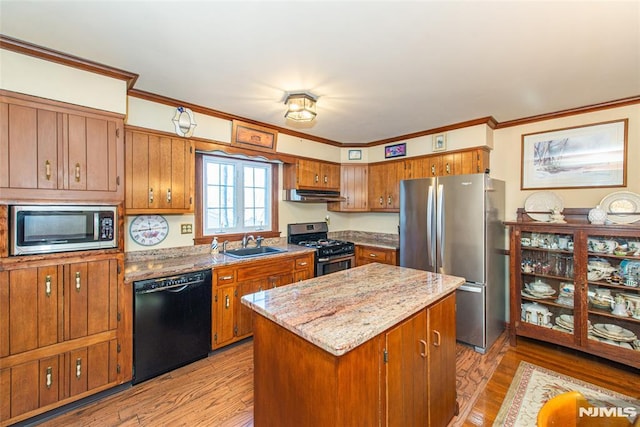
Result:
[519, 231, 576, 342]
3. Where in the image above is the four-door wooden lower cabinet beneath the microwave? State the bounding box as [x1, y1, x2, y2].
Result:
[0, 256, 126, 425]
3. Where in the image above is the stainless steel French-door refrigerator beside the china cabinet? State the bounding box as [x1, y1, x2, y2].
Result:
[400, 174, 507, 353]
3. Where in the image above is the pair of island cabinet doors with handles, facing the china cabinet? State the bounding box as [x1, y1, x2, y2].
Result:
[383, 294, 457, 426]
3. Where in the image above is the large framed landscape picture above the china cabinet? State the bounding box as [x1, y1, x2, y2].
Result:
[520, 119, 629, 190]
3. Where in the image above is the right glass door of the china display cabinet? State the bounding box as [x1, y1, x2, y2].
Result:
[587, 235, 640, 357]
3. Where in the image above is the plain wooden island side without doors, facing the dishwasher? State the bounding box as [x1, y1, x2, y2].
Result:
[253, 315, 382, 427]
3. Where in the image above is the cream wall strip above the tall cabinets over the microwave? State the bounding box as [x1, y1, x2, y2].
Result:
[0, 49, 127, 114]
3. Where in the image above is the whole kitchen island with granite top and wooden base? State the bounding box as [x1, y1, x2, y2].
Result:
[242, 263, 464, 426]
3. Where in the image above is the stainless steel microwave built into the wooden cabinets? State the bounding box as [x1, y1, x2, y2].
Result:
[9, 205, 118, 255]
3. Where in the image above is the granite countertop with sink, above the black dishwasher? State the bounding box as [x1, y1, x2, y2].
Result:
[124, 245, 315, 283]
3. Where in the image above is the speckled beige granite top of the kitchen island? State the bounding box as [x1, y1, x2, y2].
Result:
[242, 263, 464, 356]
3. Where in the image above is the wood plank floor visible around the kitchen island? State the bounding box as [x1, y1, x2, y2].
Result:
[35, 334, 640, 427]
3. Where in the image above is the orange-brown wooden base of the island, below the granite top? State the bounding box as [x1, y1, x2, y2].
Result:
[253, 293, 457, 427]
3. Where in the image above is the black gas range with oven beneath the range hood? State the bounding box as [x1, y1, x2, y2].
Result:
[287, 222, 355, 276]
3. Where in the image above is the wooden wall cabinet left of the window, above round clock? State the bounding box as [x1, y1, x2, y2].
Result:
[125, 128, 195, 214]
